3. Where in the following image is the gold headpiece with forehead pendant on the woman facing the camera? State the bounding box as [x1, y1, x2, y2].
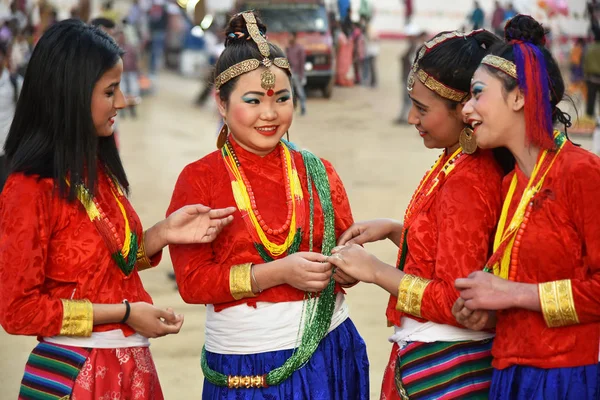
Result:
[215, 12, 290, 96]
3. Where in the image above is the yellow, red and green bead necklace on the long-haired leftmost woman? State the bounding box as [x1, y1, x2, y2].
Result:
[73, 176, 139, 276]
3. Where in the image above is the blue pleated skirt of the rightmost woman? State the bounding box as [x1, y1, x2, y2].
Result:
[490, 364, 600, 400]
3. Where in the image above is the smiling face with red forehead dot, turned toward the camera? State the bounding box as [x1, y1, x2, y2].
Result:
[216, 66, 294, 155]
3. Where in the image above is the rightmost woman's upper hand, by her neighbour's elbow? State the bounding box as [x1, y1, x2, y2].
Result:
[454, 271, 516, 310]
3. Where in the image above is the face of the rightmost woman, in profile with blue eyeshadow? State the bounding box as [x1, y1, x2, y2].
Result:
[463, 67, 525, 149]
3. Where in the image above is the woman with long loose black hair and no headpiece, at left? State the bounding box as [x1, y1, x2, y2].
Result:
[0, 20, 233, 400]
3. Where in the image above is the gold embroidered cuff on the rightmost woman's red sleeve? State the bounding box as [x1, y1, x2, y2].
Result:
[538, 279, 579, 328]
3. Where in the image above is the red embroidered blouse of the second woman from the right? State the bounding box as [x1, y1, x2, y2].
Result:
[386, 150, 503, 327]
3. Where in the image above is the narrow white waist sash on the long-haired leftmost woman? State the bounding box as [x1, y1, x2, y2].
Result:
[44, 329, 150, 349]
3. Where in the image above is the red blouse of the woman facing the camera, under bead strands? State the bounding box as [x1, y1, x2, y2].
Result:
[167, 139, 353, 311]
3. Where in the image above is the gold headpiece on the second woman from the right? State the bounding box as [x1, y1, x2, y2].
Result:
[406, 29, 483, 102]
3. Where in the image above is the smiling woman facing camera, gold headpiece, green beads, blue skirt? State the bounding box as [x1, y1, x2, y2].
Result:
[168, 12, 369, 400]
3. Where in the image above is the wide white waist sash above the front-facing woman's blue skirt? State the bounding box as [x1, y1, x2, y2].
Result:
[206, 293, 349, 354]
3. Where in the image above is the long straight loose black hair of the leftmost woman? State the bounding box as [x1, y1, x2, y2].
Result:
[4, 19, 129, 200]
